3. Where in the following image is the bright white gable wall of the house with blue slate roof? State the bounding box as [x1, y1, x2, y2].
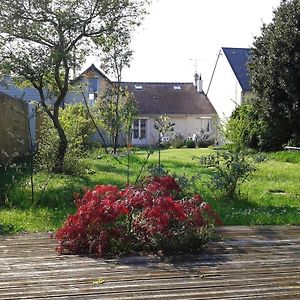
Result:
[207, 53, 242, 122]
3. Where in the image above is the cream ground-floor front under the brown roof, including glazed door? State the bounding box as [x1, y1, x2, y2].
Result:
[133, 115, 217, 145]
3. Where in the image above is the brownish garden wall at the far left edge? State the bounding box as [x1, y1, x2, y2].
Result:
[0, 93, 30, 165]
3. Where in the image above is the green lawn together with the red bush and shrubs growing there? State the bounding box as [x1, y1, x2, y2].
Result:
[0, 147, 300, 256]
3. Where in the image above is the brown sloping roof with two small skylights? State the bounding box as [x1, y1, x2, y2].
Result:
[122, 82, 216, 115]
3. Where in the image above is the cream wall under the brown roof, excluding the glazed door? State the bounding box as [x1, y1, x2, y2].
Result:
[140, 115, 217, 145]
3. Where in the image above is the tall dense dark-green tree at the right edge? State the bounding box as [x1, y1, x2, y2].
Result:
[249, 0, 300, 149]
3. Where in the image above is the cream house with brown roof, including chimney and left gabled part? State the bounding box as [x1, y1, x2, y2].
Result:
[65, 65, 217, 145]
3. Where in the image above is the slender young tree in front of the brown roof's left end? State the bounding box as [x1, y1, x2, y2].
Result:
[97, 28, 137, 153]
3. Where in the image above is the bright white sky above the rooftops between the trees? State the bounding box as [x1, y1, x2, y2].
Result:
[89, 0, 280, 89]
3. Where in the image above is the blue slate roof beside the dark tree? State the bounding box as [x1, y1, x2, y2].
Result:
[222, 47, 251, 91]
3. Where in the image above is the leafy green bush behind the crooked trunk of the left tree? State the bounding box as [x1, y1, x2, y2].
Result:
[37, 103, 94, 173]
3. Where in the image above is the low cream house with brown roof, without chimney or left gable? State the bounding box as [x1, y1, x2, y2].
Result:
[123, 82, 217, 145]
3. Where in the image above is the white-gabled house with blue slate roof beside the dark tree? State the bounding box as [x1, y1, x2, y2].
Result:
[207, 47, 251, 122]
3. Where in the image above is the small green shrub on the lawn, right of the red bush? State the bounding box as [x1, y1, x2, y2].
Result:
[200, 150, 255, 199]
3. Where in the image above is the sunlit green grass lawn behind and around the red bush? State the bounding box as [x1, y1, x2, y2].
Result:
[0, 149, 300, 233]
